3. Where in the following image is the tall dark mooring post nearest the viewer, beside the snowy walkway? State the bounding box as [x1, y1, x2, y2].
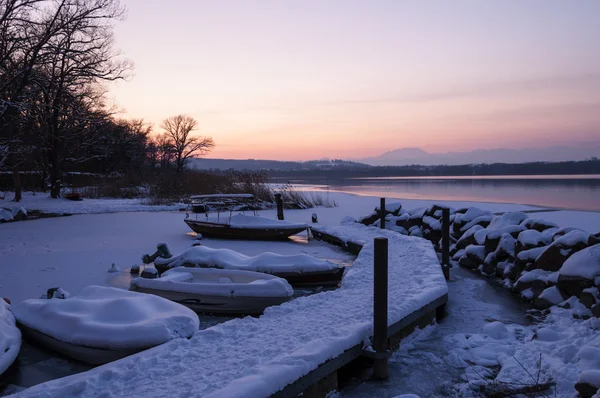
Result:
[373, 236, 388, 380]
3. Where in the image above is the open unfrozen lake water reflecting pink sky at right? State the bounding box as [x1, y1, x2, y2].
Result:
[290, 174, 600, 211]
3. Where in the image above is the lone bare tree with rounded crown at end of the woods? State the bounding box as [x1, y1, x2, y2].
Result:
[160, 115, 215, 171]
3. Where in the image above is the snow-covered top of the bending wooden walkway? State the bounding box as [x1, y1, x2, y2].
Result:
[21, 225, 448, 398]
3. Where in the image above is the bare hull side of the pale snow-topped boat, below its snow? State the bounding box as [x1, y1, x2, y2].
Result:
[131, 286, 290, 315]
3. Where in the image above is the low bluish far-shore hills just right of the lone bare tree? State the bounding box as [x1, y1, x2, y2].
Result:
[186, 158, 369, 171]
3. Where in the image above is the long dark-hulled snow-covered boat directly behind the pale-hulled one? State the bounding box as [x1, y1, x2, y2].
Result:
[154, 246, 345, 287]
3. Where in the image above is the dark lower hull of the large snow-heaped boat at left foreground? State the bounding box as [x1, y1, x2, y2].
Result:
[19, 324, 145, 365]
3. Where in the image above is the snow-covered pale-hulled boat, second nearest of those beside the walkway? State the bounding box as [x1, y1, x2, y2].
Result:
[130, 267, 294, 314]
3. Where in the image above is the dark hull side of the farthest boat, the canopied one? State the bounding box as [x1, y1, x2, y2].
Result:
[184, 219, 307, 240]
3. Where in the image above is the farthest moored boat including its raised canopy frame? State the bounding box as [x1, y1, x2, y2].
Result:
[185, 194, 308, 240]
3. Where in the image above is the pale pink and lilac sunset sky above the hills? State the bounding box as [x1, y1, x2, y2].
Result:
[109, 0, 600, 160]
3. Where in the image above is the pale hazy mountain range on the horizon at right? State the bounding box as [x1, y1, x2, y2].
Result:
[359, 144, 600, 166]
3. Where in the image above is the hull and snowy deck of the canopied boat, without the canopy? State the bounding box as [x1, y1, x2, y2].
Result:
[185, 214, 308, 240]
